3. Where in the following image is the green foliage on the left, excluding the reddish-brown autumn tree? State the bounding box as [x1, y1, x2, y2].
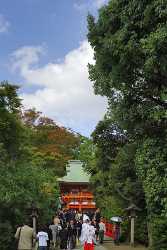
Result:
[0, 82, 59, 249]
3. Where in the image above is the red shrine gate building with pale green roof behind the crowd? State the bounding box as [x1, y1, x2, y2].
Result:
[59, 160, 96, 211]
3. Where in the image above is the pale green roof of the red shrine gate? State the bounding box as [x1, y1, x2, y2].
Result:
[59, 160, 90, 183]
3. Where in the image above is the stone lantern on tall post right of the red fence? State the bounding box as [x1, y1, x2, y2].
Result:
[125, 203, 141, 246]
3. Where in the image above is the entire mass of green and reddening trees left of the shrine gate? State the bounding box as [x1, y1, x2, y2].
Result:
[0, 82, 80, 250]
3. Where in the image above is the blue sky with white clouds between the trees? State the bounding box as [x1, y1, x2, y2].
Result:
[0, 0, 108, 136]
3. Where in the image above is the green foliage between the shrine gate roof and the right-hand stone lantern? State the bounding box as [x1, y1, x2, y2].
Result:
[79, 123, 147, 243]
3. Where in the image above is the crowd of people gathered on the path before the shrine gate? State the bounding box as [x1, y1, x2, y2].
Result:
[15, 209, 106, 250]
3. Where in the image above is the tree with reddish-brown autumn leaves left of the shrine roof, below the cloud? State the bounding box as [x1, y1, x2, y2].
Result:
[22, 109, 80, 176]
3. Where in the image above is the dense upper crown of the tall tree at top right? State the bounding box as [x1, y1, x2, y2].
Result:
[88, 1, 167, 106]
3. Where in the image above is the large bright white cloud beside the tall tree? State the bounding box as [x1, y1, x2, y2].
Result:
[12, 41, 106, 136]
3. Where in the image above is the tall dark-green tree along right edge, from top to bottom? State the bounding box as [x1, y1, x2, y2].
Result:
[88, 0, 167, 250]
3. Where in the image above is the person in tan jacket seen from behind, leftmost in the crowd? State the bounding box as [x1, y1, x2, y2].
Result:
[15, 219, 36, 250]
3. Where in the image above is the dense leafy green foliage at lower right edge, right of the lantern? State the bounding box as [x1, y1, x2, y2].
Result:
[136, 138, 167, 217]
